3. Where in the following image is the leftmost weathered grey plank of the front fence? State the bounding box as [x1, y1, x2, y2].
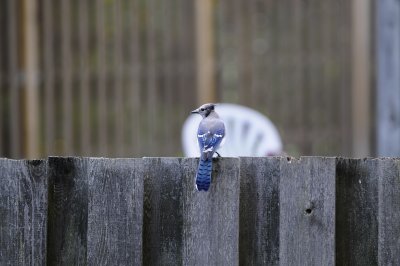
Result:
[0, 159, 47, 265]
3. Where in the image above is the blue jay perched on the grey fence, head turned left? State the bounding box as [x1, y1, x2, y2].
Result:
[192, 103, 225, 191]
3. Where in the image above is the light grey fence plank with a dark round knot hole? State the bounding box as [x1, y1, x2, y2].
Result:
[279, 157, 336, 265]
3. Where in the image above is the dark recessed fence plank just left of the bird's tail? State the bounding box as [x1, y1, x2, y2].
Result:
[143, 158, 186, 265]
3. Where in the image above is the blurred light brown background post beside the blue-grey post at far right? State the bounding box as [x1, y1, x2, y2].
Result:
[351, 0, 372, 157]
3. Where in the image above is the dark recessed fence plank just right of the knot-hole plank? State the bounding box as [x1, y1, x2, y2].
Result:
[336, 159, 379, 265]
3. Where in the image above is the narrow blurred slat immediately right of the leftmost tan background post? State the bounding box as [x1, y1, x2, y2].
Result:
[42, 0, 56, 155]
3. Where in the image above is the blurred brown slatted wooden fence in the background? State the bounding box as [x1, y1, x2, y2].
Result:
[0, 0, 375, 158]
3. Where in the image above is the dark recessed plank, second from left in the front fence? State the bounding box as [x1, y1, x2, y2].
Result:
[47, 157, 88, 265]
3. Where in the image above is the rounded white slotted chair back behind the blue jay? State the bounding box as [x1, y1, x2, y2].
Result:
[182, 103, 282, 157]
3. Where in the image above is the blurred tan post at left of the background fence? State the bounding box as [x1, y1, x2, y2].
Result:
[21, 0, 40, 158]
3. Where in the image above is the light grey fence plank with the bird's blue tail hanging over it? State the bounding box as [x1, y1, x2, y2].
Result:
[183, 158, 240, 265]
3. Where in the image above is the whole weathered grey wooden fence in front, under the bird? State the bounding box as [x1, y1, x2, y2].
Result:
[0, 157, 400, 265]
